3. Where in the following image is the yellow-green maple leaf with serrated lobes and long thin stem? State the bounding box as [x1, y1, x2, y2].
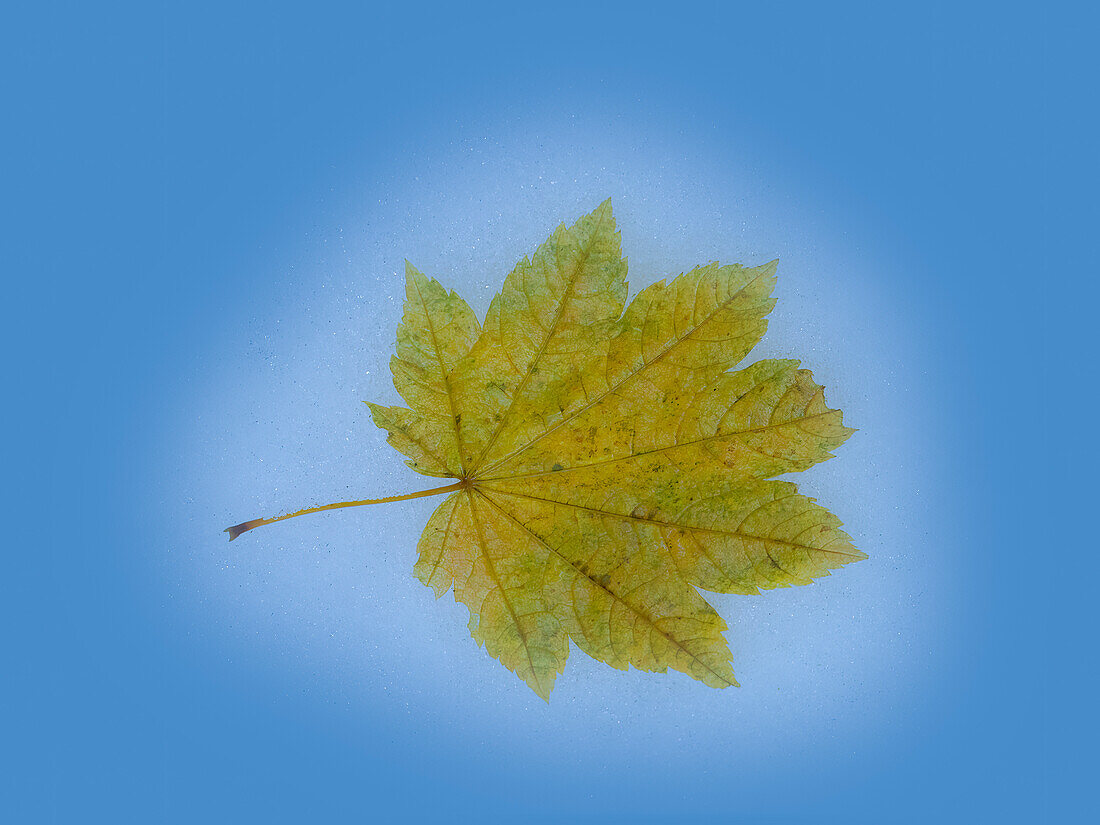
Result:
[229, 201, 866, 699]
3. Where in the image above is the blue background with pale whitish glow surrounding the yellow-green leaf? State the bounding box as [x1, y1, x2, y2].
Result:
[0, 2, 1082, 822]
